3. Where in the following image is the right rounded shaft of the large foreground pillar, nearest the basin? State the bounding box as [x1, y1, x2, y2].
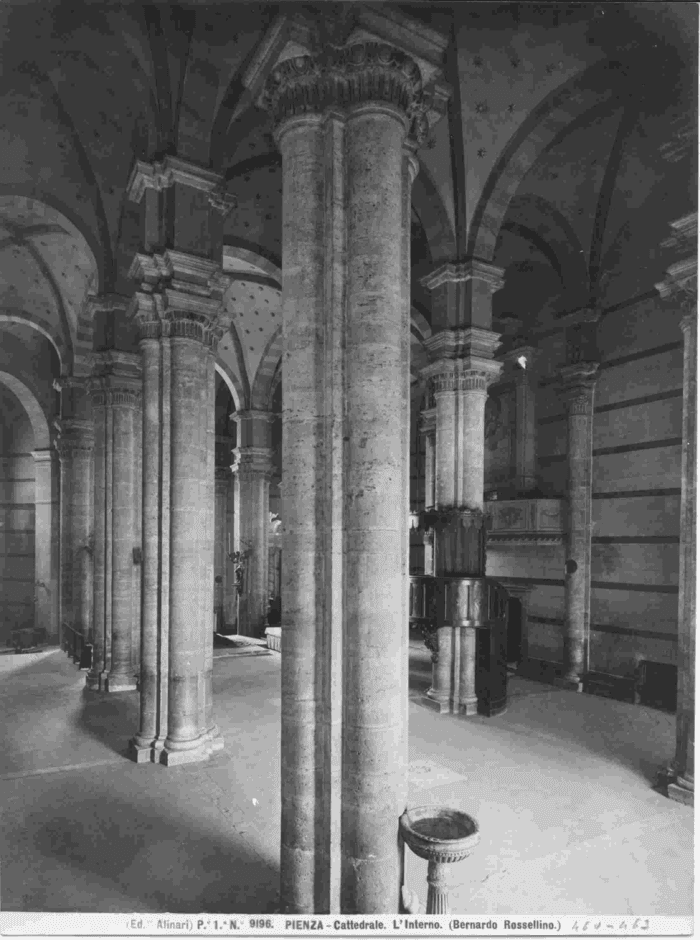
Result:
[341, 104, 410, 913]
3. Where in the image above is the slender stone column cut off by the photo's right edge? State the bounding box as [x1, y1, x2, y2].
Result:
[656, 213, 698, 806]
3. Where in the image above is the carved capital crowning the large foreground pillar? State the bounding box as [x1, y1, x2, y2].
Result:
[260, 41, 429, 142]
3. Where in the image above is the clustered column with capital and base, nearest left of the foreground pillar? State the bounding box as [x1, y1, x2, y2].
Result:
[126, 251, 223, 765]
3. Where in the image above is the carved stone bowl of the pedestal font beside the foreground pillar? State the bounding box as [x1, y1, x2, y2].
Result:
[399, 806, 479, 864]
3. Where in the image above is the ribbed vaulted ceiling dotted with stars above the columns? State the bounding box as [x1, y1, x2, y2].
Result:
[0, 0, 697, 395]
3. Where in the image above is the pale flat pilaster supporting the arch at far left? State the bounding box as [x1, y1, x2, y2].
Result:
[33, 448, 59, 642]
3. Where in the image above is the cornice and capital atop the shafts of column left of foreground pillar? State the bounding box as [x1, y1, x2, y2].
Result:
[129, 249, 226, 347]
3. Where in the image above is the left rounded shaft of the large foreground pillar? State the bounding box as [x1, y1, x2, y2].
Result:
[276, 115, 328, 913]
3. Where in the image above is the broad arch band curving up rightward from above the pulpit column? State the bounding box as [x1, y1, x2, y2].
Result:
[467, 61, 619, 262]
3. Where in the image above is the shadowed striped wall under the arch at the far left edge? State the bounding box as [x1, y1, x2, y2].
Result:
[0, 385, 35, 648]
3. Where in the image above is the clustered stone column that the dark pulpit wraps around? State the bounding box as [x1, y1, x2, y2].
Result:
[423, 278, 503, 716]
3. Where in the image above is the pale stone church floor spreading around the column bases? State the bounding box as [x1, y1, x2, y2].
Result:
[0, 641, 693, 916]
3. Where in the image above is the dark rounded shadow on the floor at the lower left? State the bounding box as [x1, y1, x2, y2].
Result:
[2, 775, 279, 913]
